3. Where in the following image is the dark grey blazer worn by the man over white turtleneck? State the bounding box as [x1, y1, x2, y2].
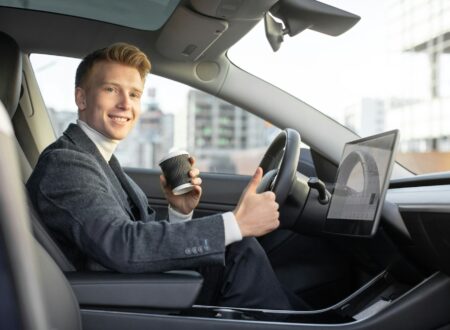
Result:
[27, 124, 225, 273]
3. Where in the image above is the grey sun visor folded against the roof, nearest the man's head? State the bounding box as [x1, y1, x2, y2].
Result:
[156, 7, 228, 62]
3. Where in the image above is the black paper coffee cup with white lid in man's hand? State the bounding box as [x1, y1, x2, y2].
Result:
[159, 150, 194, 195]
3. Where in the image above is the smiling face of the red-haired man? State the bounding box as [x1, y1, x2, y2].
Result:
[75, 61, 144, 140]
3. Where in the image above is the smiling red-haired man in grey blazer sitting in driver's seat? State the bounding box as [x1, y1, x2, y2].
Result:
[27, 43, 290, 309]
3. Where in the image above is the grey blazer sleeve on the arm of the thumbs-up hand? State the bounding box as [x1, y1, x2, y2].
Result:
[30, 150, 225, 273]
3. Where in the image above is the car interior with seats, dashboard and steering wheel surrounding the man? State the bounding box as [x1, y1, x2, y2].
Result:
[0, 0, 450, 330]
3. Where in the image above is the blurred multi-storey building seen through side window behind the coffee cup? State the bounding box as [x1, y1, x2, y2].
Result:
[187, 90, 274, 173]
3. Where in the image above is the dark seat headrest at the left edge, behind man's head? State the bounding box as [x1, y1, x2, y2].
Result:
[0, 31, 22, 117]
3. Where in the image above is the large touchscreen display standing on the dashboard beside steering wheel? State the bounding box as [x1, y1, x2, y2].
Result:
[327, 130, 398, 235]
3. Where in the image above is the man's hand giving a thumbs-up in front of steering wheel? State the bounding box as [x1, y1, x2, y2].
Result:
[233, 167, 280, 237]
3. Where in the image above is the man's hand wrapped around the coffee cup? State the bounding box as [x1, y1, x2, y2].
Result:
[159, 157, 202, 214]
